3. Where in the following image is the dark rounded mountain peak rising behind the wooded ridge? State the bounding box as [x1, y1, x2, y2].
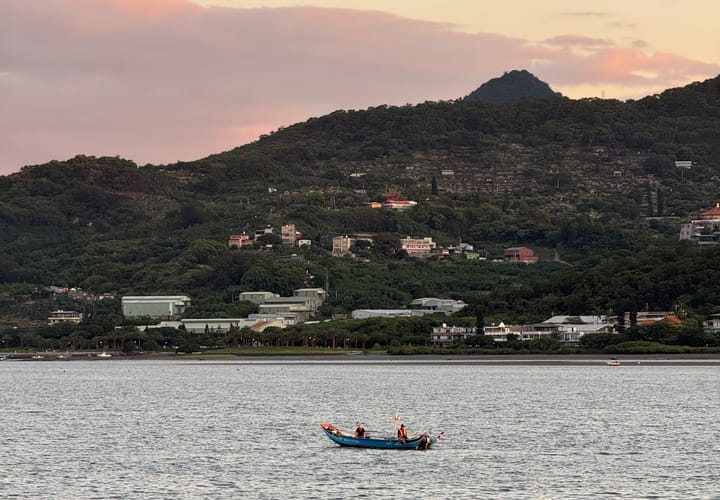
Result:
[464, 69, 561, 103]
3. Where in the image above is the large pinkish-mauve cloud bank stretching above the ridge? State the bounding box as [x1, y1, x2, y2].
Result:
[0, 0, 720, 173]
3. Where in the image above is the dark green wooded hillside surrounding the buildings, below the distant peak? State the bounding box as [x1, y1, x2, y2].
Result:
[0, 72, 720, 347]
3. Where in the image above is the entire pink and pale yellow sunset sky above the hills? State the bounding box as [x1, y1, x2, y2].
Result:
[0, 0, 720, 175]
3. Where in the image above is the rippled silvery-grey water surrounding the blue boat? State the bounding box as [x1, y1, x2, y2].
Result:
[0, 360, 720, 499]
